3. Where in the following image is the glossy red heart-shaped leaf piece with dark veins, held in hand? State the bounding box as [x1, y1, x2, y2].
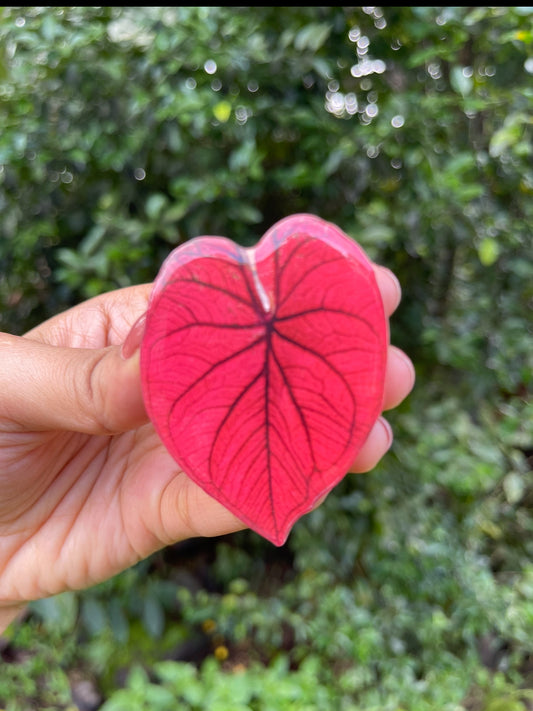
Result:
[141, 214, 388, 545]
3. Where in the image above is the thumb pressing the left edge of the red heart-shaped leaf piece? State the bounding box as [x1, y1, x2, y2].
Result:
[0, 333, 148, 434]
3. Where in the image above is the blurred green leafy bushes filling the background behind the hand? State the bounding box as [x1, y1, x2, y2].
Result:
[0, 7, 533, 711]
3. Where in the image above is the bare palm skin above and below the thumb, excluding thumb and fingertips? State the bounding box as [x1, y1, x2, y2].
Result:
[0, 287, 239, 600]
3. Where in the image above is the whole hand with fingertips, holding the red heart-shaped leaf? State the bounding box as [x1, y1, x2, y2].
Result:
[0, 267, 414, 629]
